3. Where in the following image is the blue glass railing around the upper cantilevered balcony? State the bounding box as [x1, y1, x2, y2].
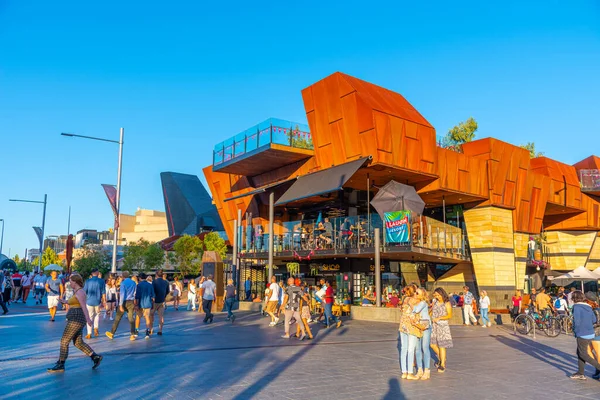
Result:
[213, 118, 313, 165]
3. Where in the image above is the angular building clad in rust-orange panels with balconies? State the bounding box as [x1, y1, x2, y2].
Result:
[204, 72, 600, 308]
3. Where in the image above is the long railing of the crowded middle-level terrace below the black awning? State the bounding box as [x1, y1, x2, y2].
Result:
[240, 214, 469, 258]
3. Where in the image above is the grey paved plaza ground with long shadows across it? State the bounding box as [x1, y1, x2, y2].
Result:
[0, 305, 600, 400]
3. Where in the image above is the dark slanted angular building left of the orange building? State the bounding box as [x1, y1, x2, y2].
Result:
[160, 172, 224, 236]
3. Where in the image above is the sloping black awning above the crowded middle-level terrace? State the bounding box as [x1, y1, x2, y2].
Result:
[275, 157, 370, 206]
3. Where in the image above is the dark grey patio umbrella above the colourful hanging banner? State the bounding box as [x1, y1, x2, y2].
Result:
[371, 181, 425, 219]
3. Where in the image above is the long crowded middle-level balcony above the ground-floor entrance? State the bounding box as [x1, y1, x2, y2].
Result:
[240, 214, 471, 264]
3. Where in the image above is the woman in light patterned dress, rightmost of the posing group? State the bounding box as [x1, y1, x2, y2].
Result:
[431, 288, 453, 372]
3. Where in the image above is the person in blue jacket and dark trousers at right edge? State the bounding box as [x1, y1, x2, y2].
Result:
[570, 290, 600, 380]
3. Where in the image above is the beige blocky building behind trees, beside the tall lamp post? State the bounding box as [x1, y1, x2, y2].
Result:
[119, 208, 169, 245]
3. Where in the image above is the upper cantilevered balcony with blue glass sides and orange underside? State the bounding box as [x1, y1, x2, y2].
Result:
[213, 118, 314, 176]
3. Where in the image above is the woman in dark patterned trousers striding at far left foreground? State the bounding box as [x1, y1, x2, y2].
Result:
[48, 273, 102, 372]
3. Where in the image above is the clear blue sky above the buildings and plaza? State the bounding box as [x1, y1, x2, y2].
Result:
[0, 0, 600, 255]
